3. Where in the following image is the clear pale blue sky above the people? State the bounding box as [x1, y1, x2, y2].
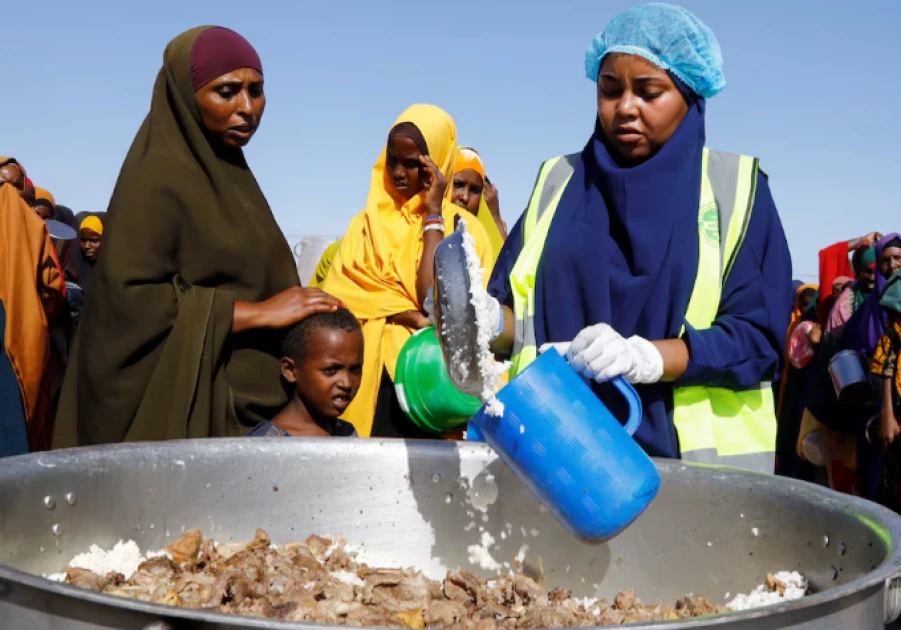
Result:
[0, 0, 901, 276]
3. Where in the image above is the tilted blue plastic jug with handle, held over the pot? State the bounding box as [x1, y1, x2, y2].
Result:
[467, 350, 660, 543]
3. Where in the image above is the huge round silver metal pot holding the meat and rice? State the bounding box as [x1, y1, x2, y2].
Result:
[0, 438, 901, 630]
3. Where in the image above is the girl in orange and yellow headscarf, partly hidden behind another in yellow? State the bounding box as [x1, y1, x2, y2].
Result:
[451, 147, 507, 265]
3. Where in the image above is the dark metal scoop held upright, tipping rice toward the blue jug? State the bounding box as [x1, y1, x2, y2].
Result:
[434, 221, 483, 397]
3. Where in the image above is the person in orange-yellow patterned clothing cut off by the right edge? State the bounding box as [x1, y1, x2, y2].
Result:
[870, 272, 901, 512]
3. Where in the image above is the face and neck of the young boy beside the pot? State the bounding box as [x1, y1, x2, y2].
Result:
[272, 328, 363, 436]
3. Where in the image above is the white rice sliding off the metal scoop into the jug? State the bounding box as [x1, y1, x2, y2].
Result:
[460, 219, 510, 417]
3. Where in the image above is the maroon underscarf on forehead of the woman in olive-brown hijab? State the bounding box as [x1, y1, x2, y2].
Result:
[191, 26, 263, 92]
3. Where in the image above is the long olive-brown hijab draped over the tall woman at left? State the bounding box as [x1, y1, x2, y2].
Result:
[54, 27, 299, 447]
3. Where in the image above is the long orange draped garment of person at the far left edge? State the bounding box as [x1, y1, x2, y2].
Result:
[0, 183, 63, 450]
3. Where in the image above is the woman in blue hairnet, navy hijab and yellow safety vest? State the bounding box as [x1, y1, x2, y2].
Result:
[489, 4, 792, 472]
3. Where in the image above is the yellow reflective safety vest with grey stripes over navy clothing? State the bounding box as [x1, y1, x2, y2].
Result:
[510, 149, 776, 473]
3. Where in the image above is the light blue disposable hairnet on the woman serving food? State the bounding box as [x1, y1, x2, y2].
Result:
[585, 2, 726, 98]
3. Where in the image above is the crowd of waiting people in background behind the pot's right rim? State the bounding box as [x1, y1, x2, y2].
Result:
[776, 232, 901, 510]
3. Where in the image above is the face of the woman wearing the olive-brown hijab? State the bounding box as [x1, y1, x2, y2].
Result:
[195, 68, 266, 149]
